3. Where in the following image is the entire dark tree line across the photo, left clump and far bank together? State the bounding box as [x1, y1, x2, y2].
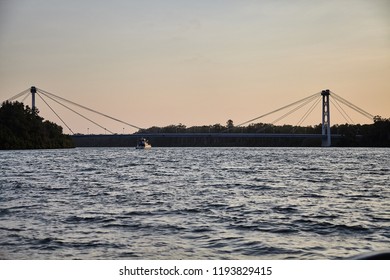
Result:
[0, 101, 390, 149]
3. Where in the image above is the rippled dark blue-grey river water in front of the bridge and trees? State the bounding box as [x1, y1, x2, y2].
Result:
[0, 148, 390, 259]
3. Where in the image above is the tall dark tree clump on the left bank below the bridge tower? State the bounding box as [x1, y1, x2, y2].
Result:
[0, 101, 74, 150]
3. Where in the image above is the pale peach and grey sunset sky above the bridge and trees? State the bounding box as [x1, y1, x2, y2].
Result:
[0, 0, 390, 133]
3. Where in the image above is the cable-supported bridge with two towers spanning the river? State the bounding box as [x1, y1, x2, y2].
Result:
[3, 86, 374, 147]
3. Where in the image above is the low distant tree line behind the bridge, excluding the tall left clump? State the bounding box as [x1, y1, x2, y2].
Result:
[73, 117, 390, 147]
